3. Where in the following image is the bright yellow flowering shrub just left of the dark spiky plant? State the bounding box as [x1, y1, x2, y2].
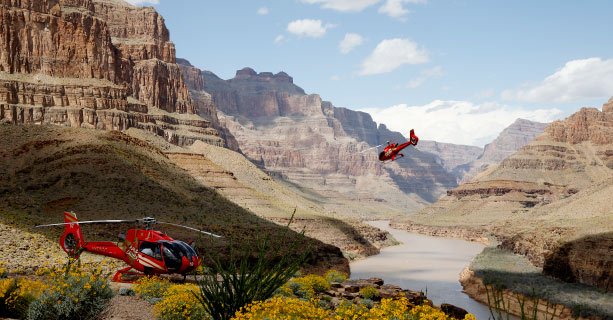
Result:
[153, 284, 207, 320]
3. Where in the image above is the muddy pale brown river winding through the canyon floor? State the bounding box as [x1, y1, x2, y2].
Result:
[350, 221, 491, 320]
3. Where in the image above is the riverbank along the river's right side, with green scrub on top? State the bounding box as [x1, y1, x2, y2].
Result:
[391, 222, 613, 320]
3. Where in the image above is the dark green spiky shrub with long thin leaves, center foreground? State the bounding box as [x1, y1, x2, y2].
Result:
[198, 210, 310, 320]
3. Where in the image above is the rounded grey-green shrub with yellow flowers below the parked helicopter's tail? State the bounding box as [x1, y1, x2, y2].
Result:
[28, 262, 113, 320]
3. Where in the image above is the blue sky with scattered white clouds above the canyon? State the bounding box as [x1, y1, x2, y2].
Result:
[128, 0, 613, 146]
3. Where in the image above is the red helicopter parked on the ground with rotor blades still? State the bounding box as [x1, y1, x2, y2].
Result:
[36, 212, 221, 282]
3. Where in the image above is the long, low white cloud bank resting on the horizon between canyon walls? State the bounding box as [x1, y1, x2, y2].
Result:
[361, 100, 563, 146]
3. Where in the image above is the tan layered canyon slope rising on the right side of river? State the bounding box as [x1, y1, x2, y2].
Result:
[396, 100, 613, 286]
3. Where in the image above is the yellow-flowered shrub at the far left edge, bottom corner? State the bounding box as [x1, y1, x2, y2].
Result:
[0, 278, 45, 318]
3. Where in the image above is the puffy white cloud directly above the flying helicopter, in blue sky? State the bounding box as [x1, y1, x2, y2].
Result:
[359, 38, 429, 75]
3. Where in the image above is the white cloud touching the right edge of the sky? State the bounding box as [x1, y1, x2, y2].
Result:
[502, 58, 613, 103]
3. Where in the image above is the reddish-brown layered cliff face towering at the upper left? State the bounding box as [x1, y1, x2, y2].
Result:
[0, 0, 223, 145]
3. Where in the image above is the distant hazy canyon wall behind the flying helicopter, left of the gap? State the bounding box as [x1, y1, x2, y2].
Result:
[201, 68, 455, 216]
